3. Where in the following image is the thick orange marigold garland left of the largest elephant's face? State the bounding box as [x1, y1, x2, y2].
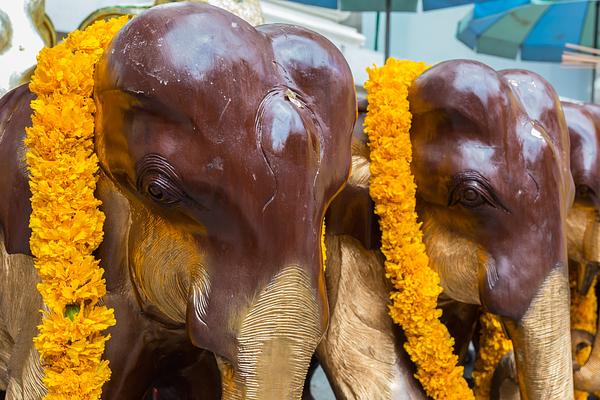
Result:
[25, 17, 127, 400]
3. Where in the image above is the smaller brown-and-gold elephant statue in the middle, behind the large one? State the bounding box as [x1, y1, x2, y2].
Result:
[318, 60, 573, 399]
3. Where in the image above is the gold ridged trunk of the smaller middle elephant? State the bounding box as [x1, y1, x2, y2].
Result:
[504, 268, 573, 400]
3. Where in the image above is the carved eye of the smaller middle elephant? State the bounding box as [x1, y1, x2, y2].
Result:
[448, 171, 508, 212]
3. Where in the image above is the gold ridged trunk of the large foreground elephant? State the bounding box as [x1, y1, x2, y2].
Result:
[217, 266, 324, 400]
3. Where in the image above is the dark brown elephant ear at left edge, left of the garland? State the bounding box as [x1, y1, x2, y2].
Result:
[0, 85, 34, 255]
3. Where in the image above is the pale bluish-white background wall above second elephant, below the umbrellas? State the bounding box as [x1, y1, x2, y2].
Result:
[363, 6, 592, 101]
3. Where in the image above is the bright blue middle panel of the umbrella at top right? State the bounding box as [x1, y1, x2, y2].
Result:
[521, 1, 588, 61]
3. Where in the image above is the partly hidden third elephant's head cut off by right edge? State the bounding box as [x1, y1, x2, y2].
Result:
[563, 102, 600, 392]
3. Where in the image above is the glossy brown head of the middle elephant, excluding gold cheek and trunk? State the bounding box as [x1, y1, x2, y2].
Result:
[411, 61, 572, 319]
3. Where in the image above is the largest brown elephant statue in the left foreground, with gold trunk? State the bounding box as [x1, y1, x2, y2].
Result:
[0, 3, 356, 399]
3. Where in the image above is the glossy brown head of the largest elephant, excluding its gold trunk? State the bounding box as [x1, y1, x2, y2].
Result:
[95, 4, 356, 367]
